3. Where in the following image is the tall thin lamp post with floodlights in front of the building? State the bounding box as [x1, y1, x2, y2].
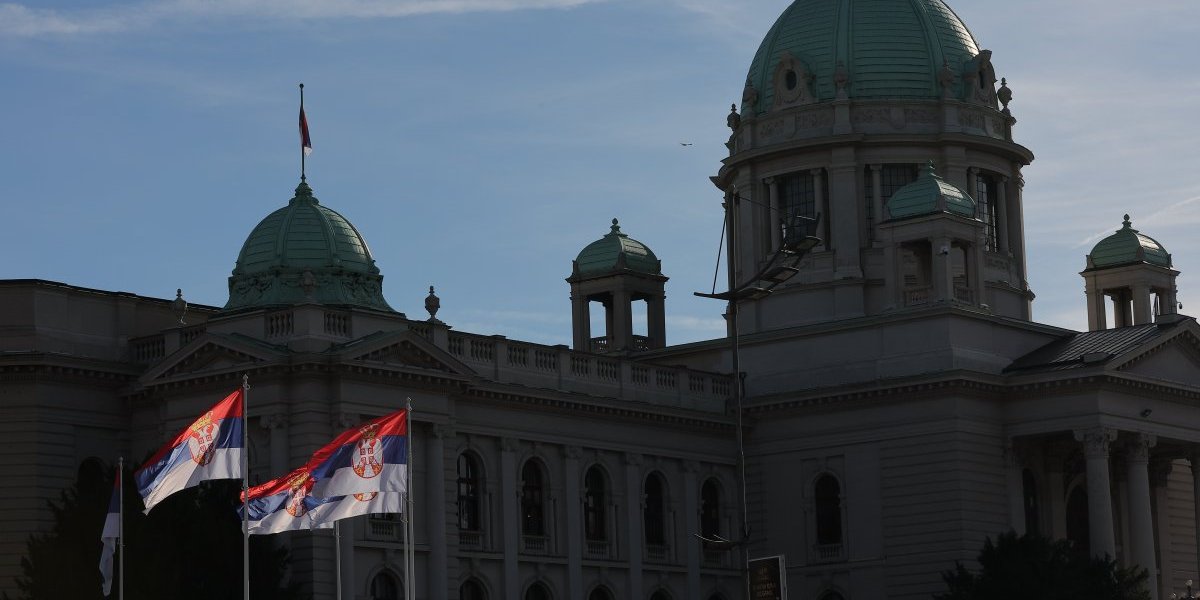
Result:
[695, 188, 821, 593]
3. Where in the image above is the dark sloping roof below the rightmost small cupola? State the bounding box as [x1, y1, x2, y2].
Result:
[1004, 320, 1182, 373]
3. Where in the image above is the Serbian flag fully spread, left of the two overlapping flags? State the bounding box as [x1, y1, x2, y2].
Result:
[133, 389, 246, 512]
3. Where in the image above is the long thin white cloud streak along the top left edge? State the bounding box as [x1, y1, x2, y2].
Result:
[0, 0, 602, 37]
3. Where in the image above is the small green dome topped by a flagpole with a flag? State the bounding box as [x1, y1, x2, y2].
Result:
[224, 181, 392, 311]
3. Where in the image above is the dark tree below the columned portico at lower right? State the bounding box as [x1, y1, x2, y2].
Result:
[936, 532, 1150, 600]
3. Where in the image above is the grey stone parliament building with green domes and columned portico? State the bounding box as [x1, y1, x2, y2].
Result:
[0, 0, 1200, 600]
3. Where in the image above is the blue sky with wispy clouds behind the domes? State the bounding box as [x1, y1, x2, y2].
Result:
[0, 0, 1200, 343]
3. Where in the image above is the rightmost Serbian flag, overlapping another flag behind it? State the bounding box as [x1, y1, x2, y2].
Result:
[306, 409, 408, 498]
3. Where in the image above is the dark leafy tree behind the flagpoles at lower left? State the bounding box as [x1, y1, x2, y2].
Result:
[5, 461, 298, 600]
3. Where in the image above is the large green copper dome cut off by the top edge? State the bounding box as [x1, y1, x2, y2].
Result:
[743, 0, 990, 114]
